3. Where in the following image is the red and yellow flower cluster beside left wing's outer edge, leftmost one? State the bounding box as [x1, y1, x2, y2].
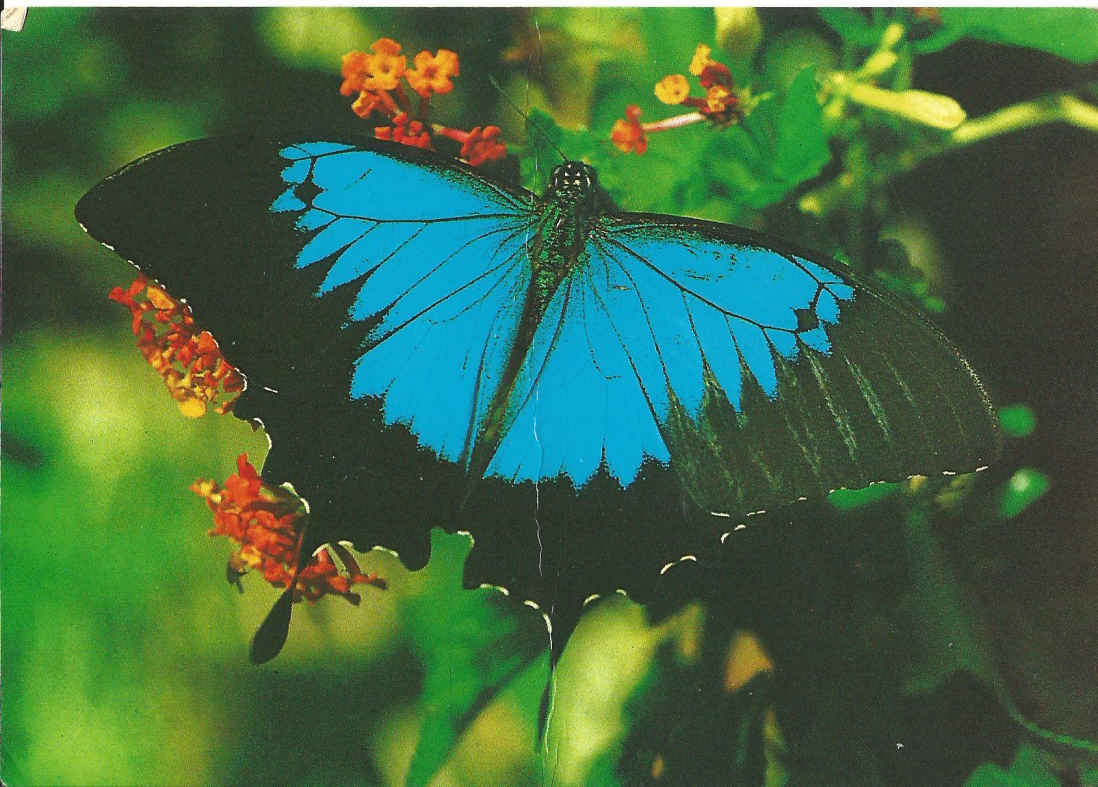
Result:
[110, 273, 244, 418]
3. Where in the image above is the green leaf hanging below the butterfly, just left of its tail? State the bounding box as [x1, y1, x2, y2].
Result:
[405, 529, 547, 785]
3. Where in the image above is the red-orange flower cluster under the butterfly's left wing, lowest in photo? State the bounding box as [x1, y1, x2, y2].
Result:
[191, 453, 386, 604]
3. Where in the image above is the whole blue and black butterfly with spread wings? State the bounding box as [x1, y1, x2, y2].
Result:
[76, 137, 1000, 652]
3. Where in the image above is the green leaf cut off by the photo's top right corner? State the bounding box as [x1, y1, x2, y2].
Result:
[940, 8, 1098, 64]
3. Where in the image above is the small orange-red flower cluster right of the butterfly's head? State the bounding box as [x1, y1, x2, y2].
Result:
[610, 44, 741, 156]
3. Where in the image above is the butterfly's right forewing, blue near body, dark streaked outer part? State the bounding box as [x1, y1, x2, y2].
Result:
[593, 215, 999, 513]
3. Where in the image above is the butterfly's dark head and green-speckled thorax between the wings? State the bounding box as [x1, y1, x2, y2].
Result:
[529, 161, 612, 316]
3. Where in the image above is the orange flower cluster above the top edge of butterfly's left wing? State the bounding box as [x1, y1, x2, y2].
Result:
[339, 38, 507, 167]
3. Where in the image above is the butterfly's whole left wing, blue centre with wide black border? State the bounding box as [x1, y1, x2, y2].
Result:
[77, 137, 542, 581]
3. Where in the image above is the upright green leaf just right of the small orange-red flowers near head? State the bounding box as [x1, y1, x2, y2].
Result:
[773, 67, 831, 184]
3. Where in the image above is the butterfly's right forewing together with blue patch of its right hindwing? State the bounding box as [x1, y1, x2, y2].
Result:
[489, 214, 999, 513]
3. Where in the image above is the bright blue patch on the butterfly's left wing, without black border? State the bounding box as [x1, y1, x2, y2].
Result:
[272, 143, 533, 462]
